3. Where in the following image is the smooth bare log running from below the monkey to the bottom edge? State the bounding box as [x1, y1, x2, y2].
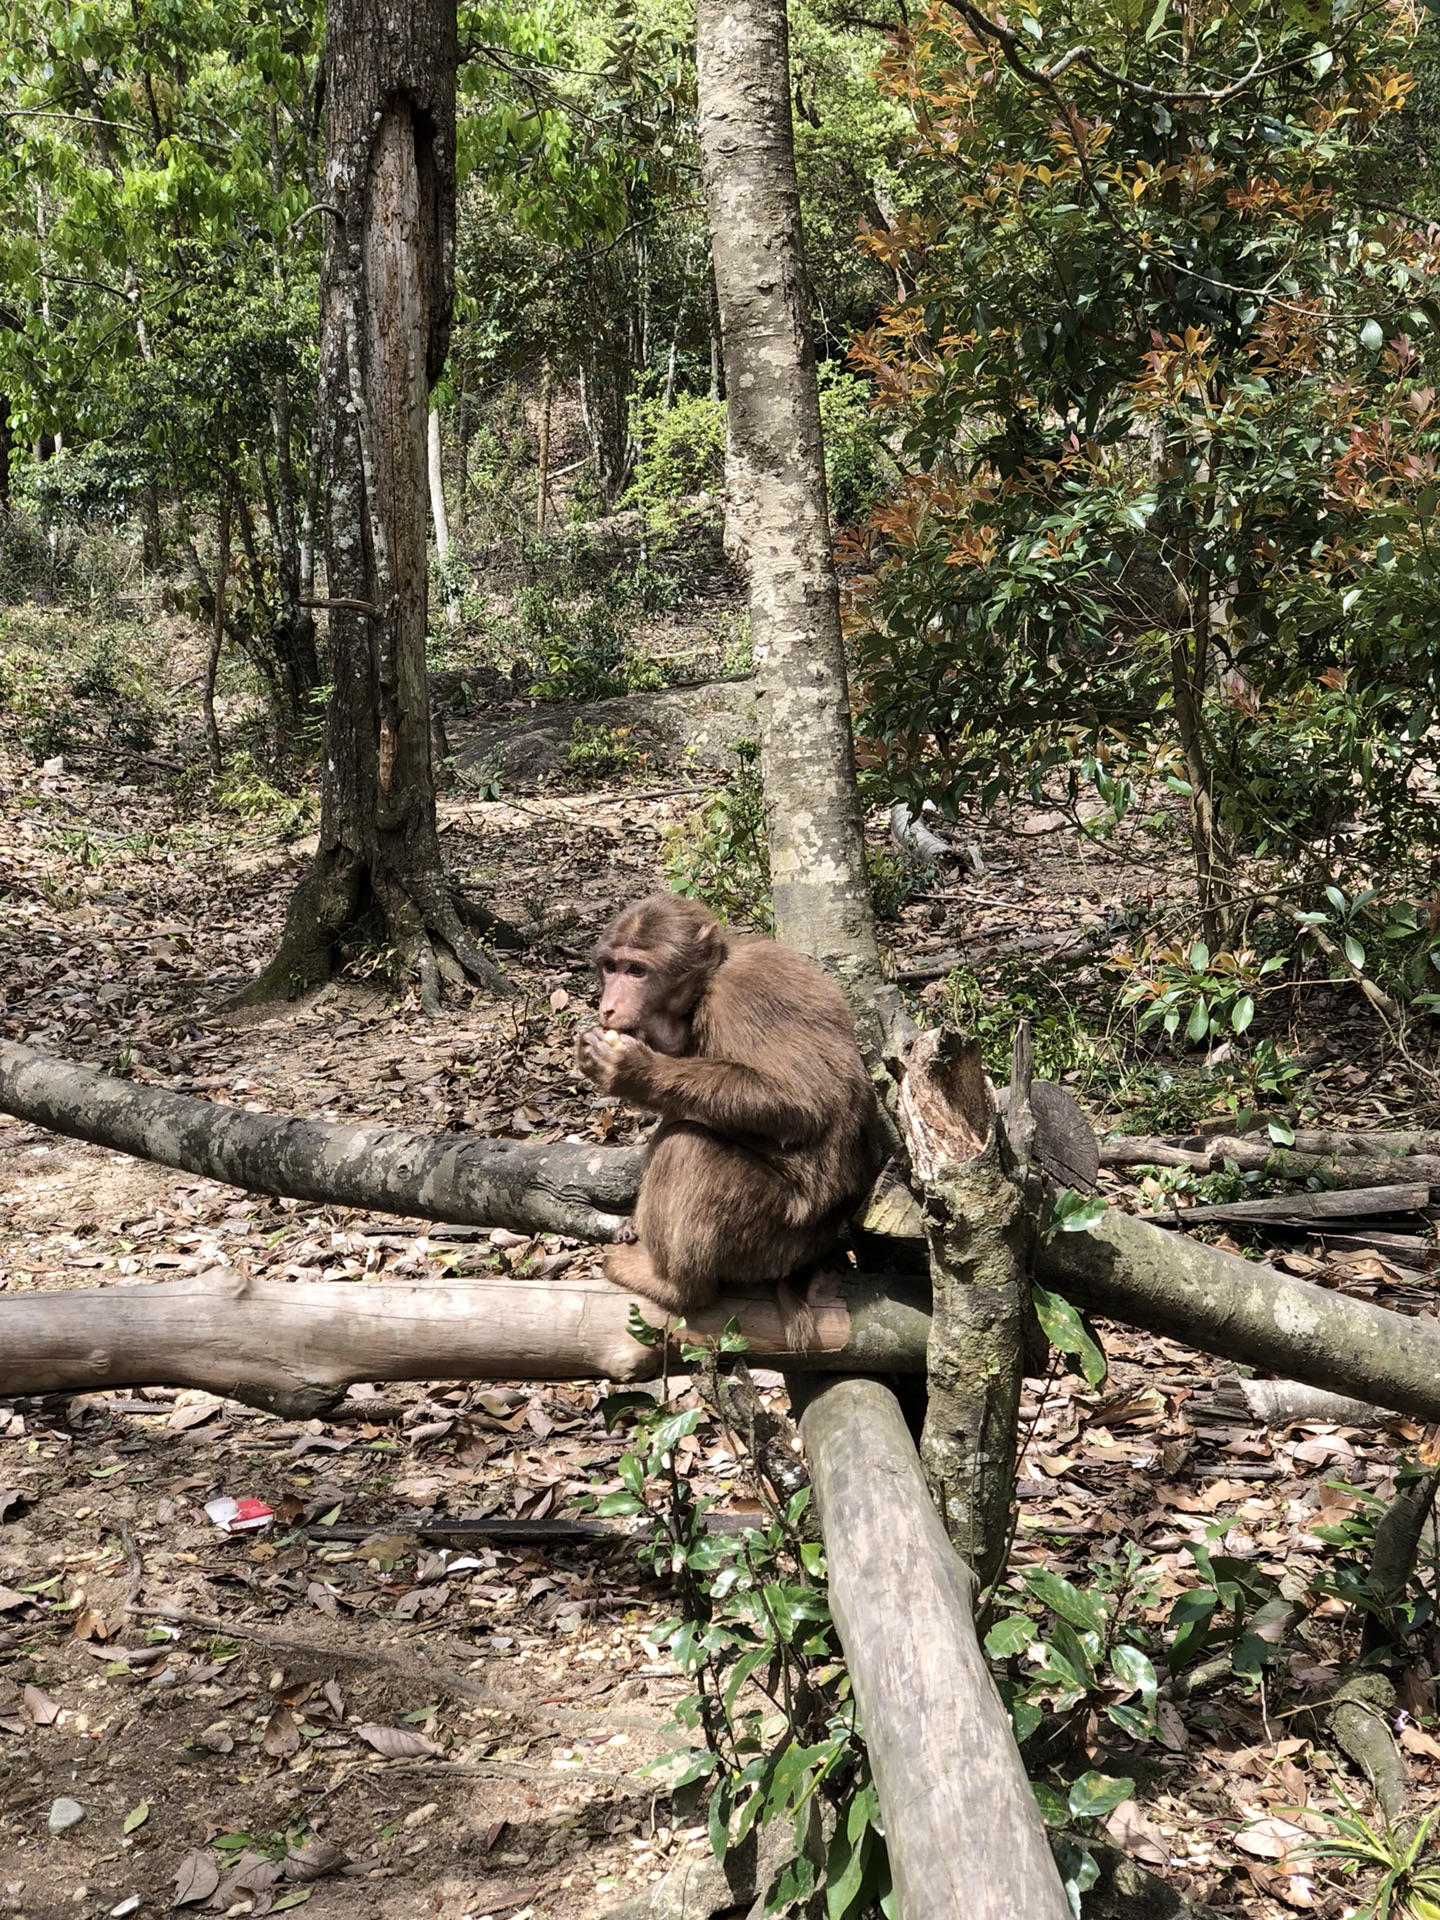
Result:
[801, 1380, 1069, 1920]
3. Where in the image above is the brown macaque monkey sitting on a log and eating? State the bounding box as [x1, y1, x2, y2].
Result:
[576, 893, 879, 1313]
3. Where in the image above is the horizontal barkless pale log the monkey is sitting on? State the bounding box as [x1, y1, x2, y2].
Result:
[0, 1269, 929, 1415]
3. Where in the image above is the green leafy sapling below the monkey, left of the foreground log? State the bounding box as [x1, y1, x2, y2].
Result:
[597, 1323, 891, 1920]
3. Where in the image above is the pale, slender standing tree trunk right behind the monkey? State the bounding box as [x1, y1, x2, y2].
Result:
[695, 0, 898, 1041]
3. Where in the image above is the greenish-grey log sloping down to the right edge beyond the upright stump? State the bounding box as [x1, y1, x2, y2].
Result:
[1035, 1210, 1440, 1421]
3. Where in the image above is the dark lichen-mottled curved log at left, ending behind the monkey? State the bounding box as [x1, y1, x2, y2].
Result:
[0, 1041, 639, 1240]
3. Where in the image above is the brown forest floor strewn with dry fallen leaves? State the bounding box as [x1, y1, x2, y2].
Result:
[0, 602, 1440, 1920]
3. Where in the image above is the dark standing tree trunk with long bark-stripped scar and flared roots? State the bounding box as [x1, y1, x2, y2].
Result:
[242, 0, 503, 1012]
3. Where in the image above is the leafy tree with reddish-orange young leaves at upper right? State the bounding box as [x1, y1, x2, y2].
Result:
[851, 0, 1440, 910]
